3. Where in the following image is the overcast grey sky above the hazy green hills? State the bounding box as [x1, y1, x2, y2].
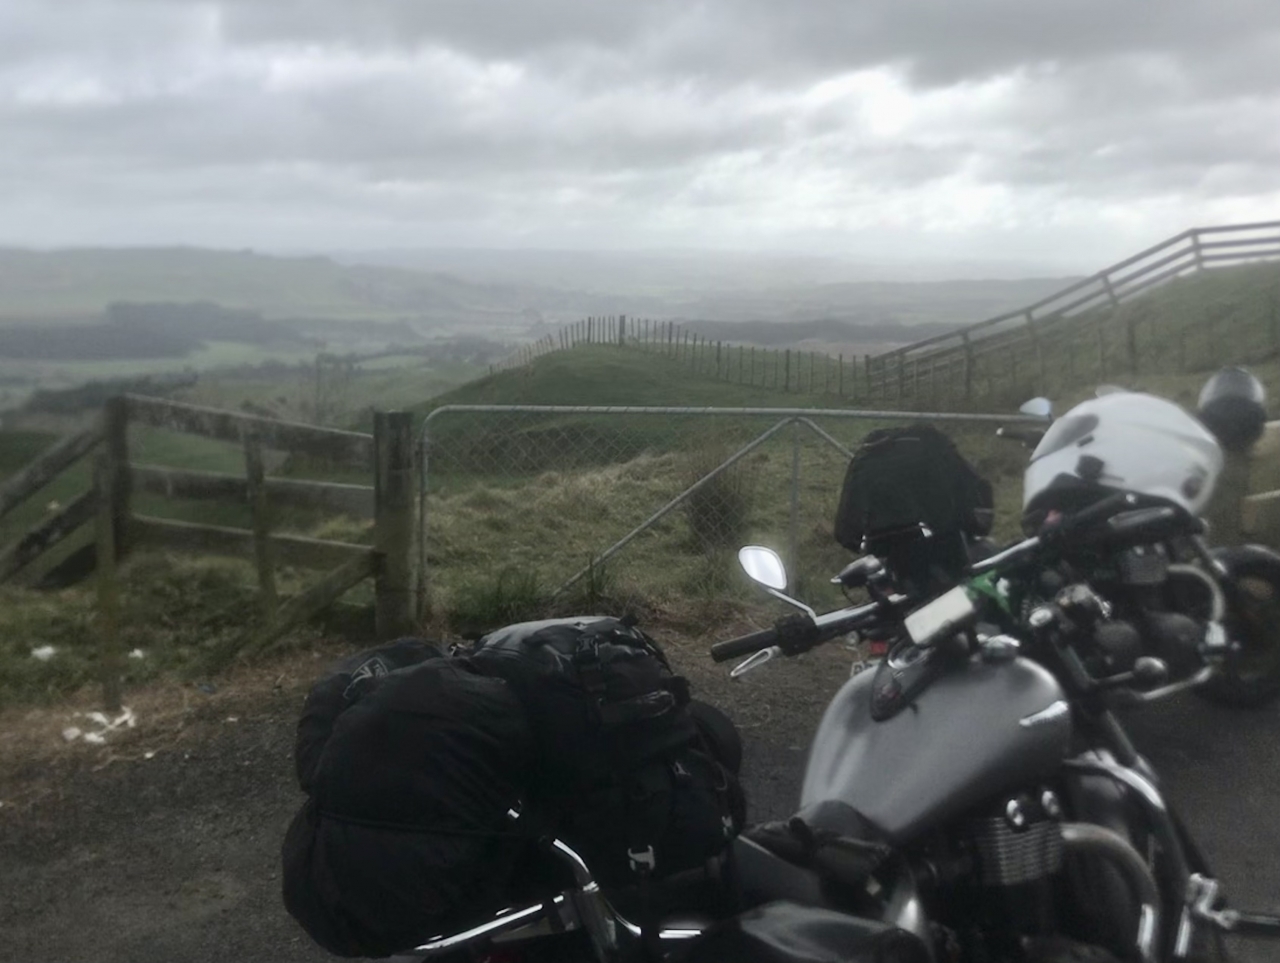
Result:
[0, 0, 1280, 270]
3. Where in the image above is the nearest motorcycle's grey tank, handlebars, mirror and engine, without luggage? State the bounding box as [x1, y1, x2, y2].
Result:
[712, 514, 1280, 963]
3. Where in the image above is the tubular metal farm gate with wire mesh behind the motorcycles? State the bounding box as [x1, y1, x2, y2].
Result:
[419, 406, 1044, 631]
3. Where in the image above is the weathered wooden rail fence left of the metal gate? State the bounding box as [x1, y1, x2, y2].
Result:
[0, 396, 416, 711]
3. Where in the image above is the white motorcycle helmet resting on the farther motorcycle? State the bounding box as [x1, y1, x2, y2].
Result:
[1023, 391, 1222, 528]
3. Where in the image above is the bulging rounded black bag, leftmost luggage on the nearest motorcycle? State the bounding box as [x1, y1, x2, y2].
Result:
[283, 642, 532, 957]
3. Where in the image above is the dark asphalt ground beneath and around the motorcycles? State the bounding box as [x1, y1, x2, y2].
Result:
[0, 651, 1280, 963]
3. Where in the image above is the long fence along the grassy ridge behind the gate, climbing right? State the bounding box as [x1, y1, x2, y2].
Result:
[490, 222, 1280, 409]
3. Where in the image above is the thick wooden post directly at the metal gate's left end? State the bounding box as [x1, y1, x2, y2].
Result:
[374, 411, 413, 639]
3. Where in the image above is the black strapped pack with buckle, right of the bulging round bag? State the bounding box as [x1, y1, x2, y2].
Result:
[471, 617, 746, 887]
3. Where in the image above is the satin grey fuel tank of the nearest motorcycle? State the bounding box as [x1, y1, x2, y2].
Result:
[800, 658, 1071, 843]
